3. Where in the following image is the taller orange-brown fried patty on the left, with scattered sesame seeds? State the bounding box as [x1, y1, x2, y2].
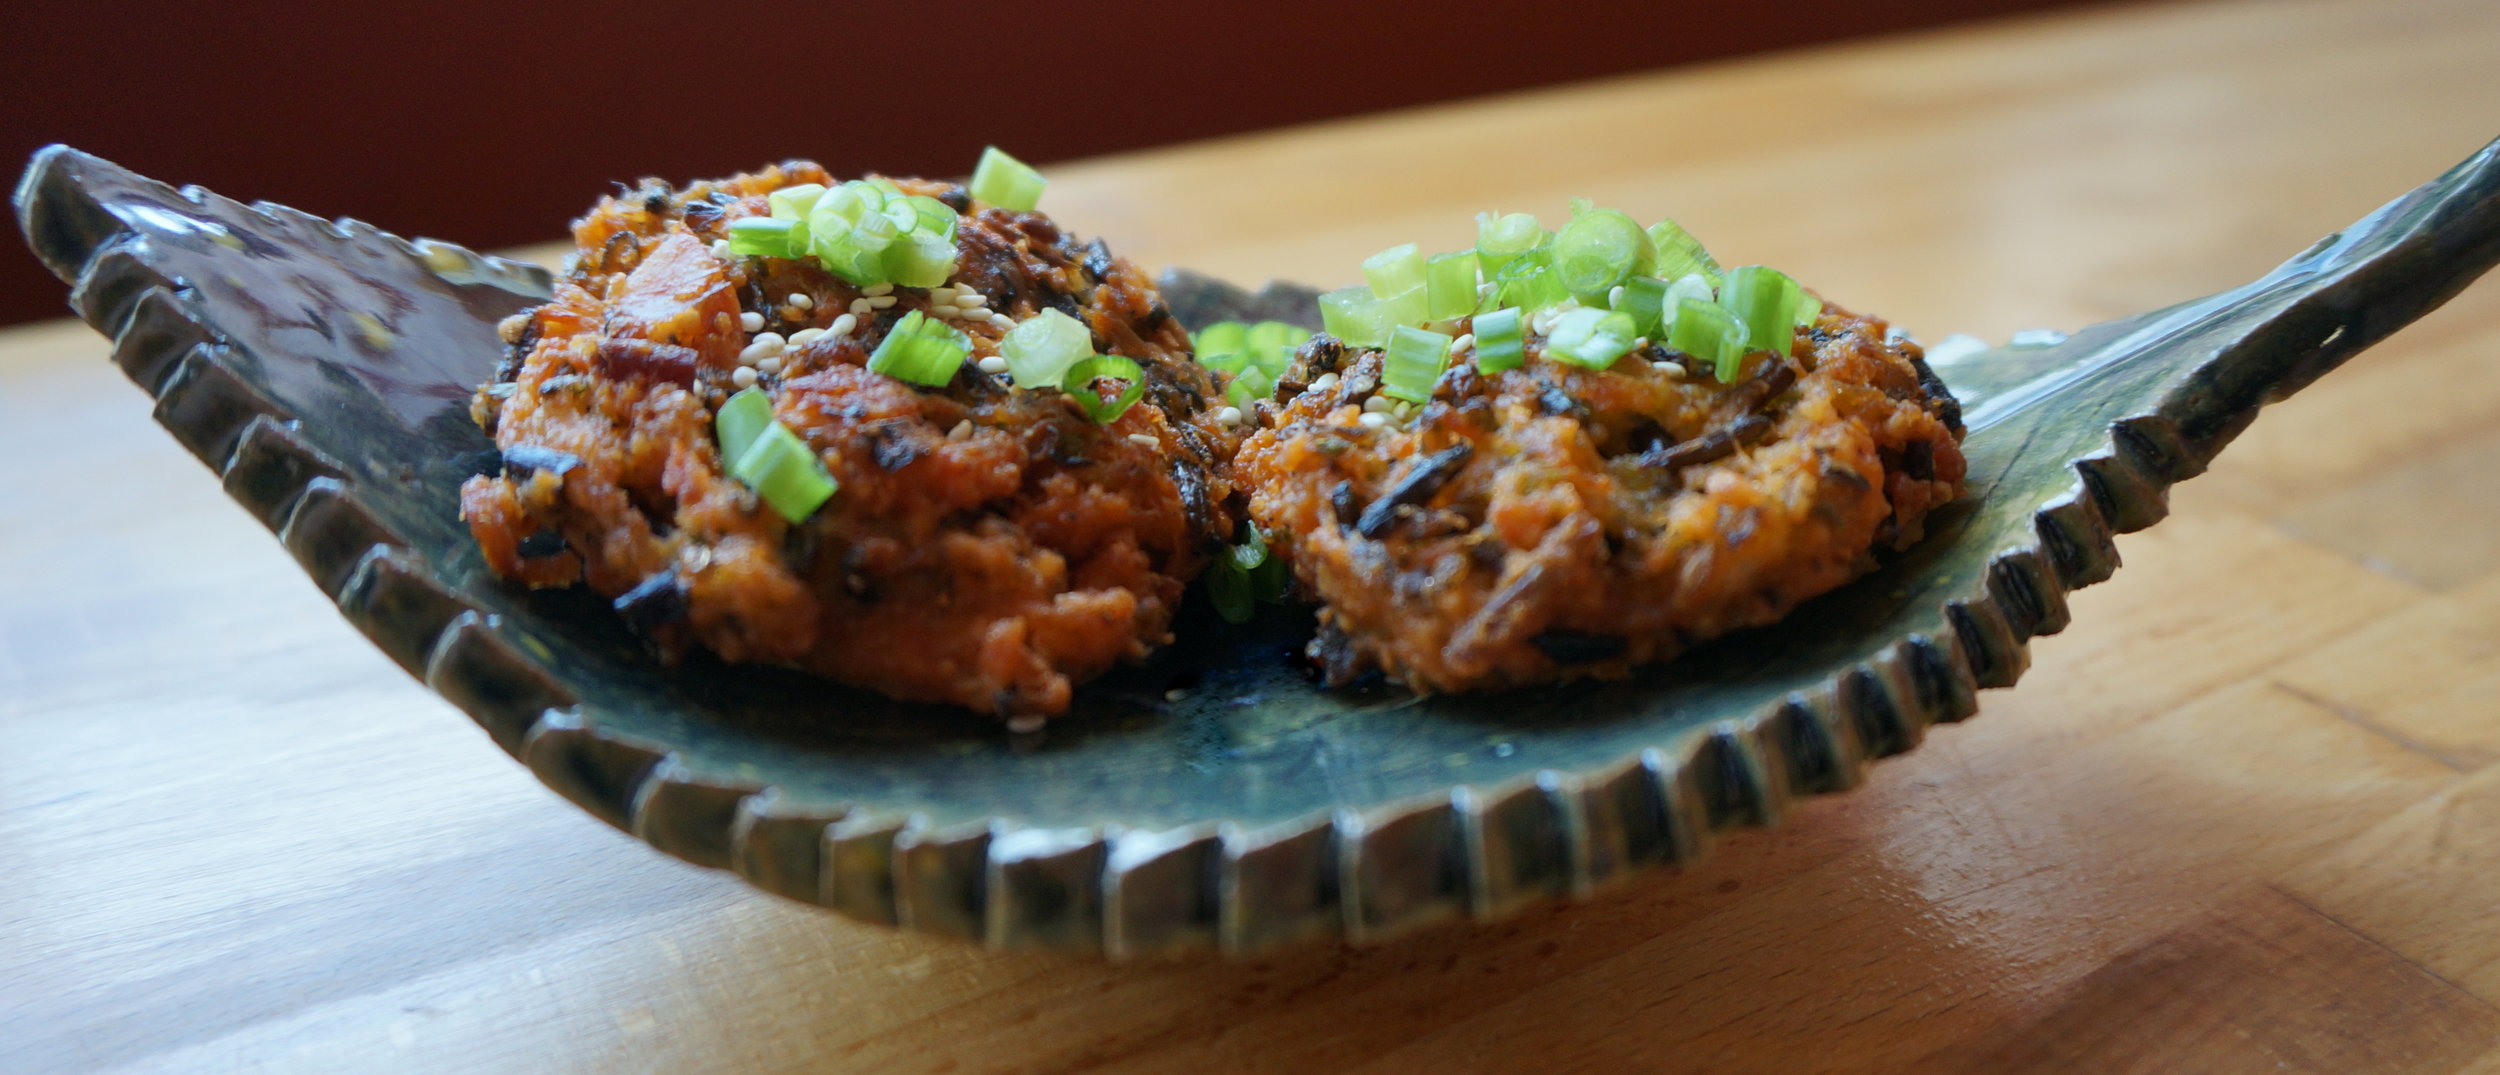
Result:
[460, 163, 1238, 718]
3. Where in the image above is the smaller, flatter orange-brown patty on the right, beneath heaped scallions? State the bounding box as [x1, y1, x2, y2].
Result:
[1233, 305, 1963, 693]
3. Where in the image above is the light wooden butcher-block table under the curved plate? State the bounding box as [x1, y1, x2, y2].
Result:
[0, 0, 2500, 1073]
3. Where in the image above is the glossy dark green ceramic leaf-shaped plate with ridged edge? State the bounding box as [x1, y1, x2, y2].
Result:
[18, 148, 2500, 958]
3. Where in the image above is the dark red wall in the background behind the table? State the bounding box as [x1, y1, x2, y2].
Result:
[0, 0, 2065, 323]
